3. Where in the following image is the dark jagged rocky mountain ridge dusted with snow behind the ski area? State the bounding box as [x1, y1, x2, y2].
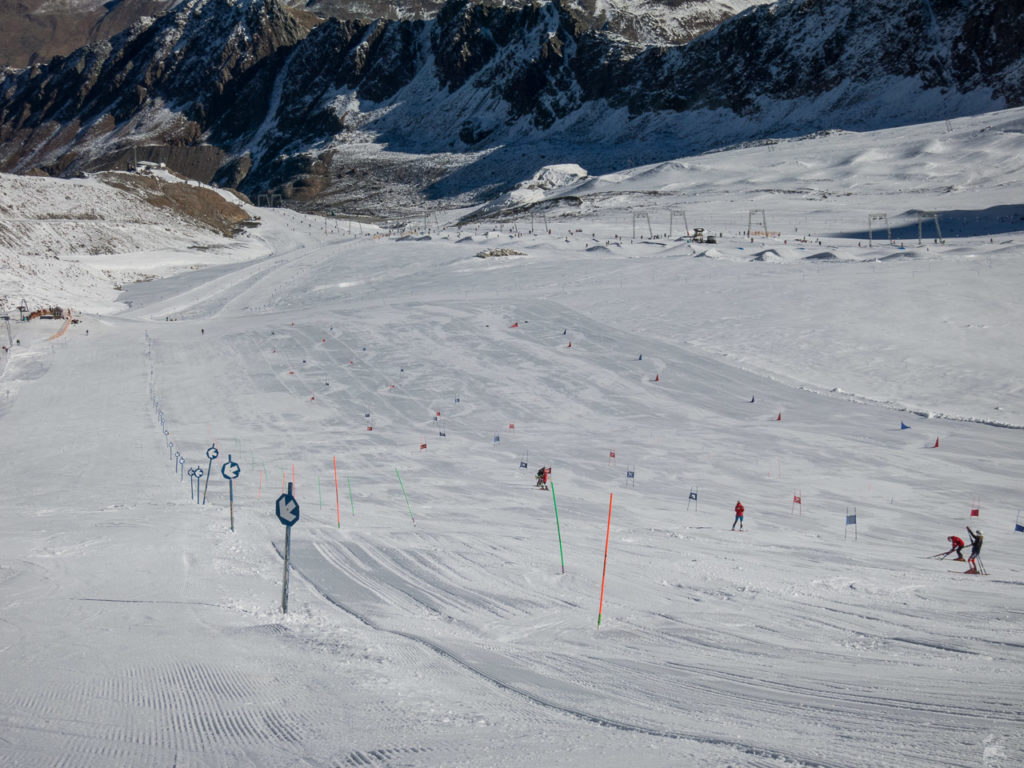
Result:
[0, 0, 1024, 207]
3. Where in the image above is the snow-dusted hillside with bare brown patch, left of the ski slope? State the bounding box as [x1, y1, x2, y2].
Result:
[0, 169, 260, 316]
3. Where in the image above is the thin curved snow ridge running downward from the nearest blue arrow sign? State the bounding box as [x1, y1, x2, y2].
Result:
[271, 542, 841, 768]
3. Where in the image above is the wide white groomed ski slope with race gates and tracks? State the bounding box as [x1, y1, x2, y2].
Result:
[6, 112, 1024, 768]
